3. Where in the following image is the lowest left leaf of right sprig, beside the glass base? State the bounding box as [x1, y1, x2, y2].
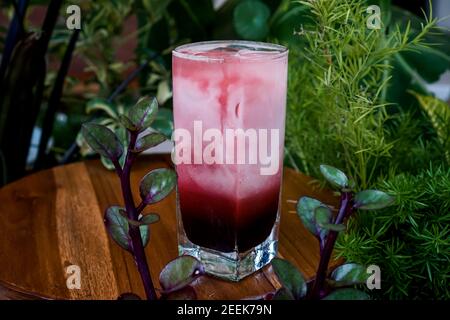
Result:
[272, 258, 307, 300]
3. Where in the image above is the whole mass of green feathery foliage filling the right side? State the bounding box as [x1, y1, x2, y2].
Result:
[286, 0, 450, 299]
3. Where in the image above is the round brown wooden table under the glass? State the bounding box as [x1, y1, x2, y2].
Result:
[0, 156, 336, 299]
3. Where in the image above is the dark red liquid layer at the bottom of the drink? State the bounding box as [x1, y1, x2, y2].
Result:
[178, 185, 280, 252]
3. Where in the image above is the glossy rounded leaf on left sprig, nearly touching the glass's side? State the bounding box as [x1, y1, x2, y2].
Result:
[139, 168, 177, 204]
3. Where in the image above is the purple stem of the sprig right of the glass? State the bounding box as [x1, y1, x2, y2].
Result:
[311, 192, 353, 299]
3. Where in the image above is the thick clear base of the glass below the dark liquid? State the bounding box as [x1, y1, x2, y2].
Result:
[178, 226, 278, 281]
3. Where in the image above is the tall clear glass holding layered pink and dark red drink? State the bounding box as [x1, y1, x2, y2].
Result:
[172, 41, 288, 281]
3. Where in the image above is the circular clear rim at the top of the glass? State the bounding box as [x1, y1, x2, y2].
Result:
[172, 40, 289, 62]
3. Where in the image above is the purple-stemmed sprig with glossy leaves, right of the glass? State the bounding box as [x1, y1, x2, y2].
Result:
[267, 165, 394, 300]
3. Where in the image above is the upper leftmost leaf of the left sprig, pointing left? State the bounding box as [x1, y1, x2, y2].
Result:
[81, 123, 123, 161]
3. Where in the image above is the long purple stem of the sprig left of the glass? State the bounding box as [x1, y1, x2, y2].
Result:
[116, 132, 157, 300]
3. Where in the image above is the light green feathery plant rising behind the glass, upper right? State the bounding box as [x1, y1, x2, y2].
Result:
[286, 0, 447, 188]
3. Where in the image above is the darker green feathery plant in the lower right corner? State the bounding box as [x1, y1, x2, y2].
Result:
[336, 166, 450, 300]
